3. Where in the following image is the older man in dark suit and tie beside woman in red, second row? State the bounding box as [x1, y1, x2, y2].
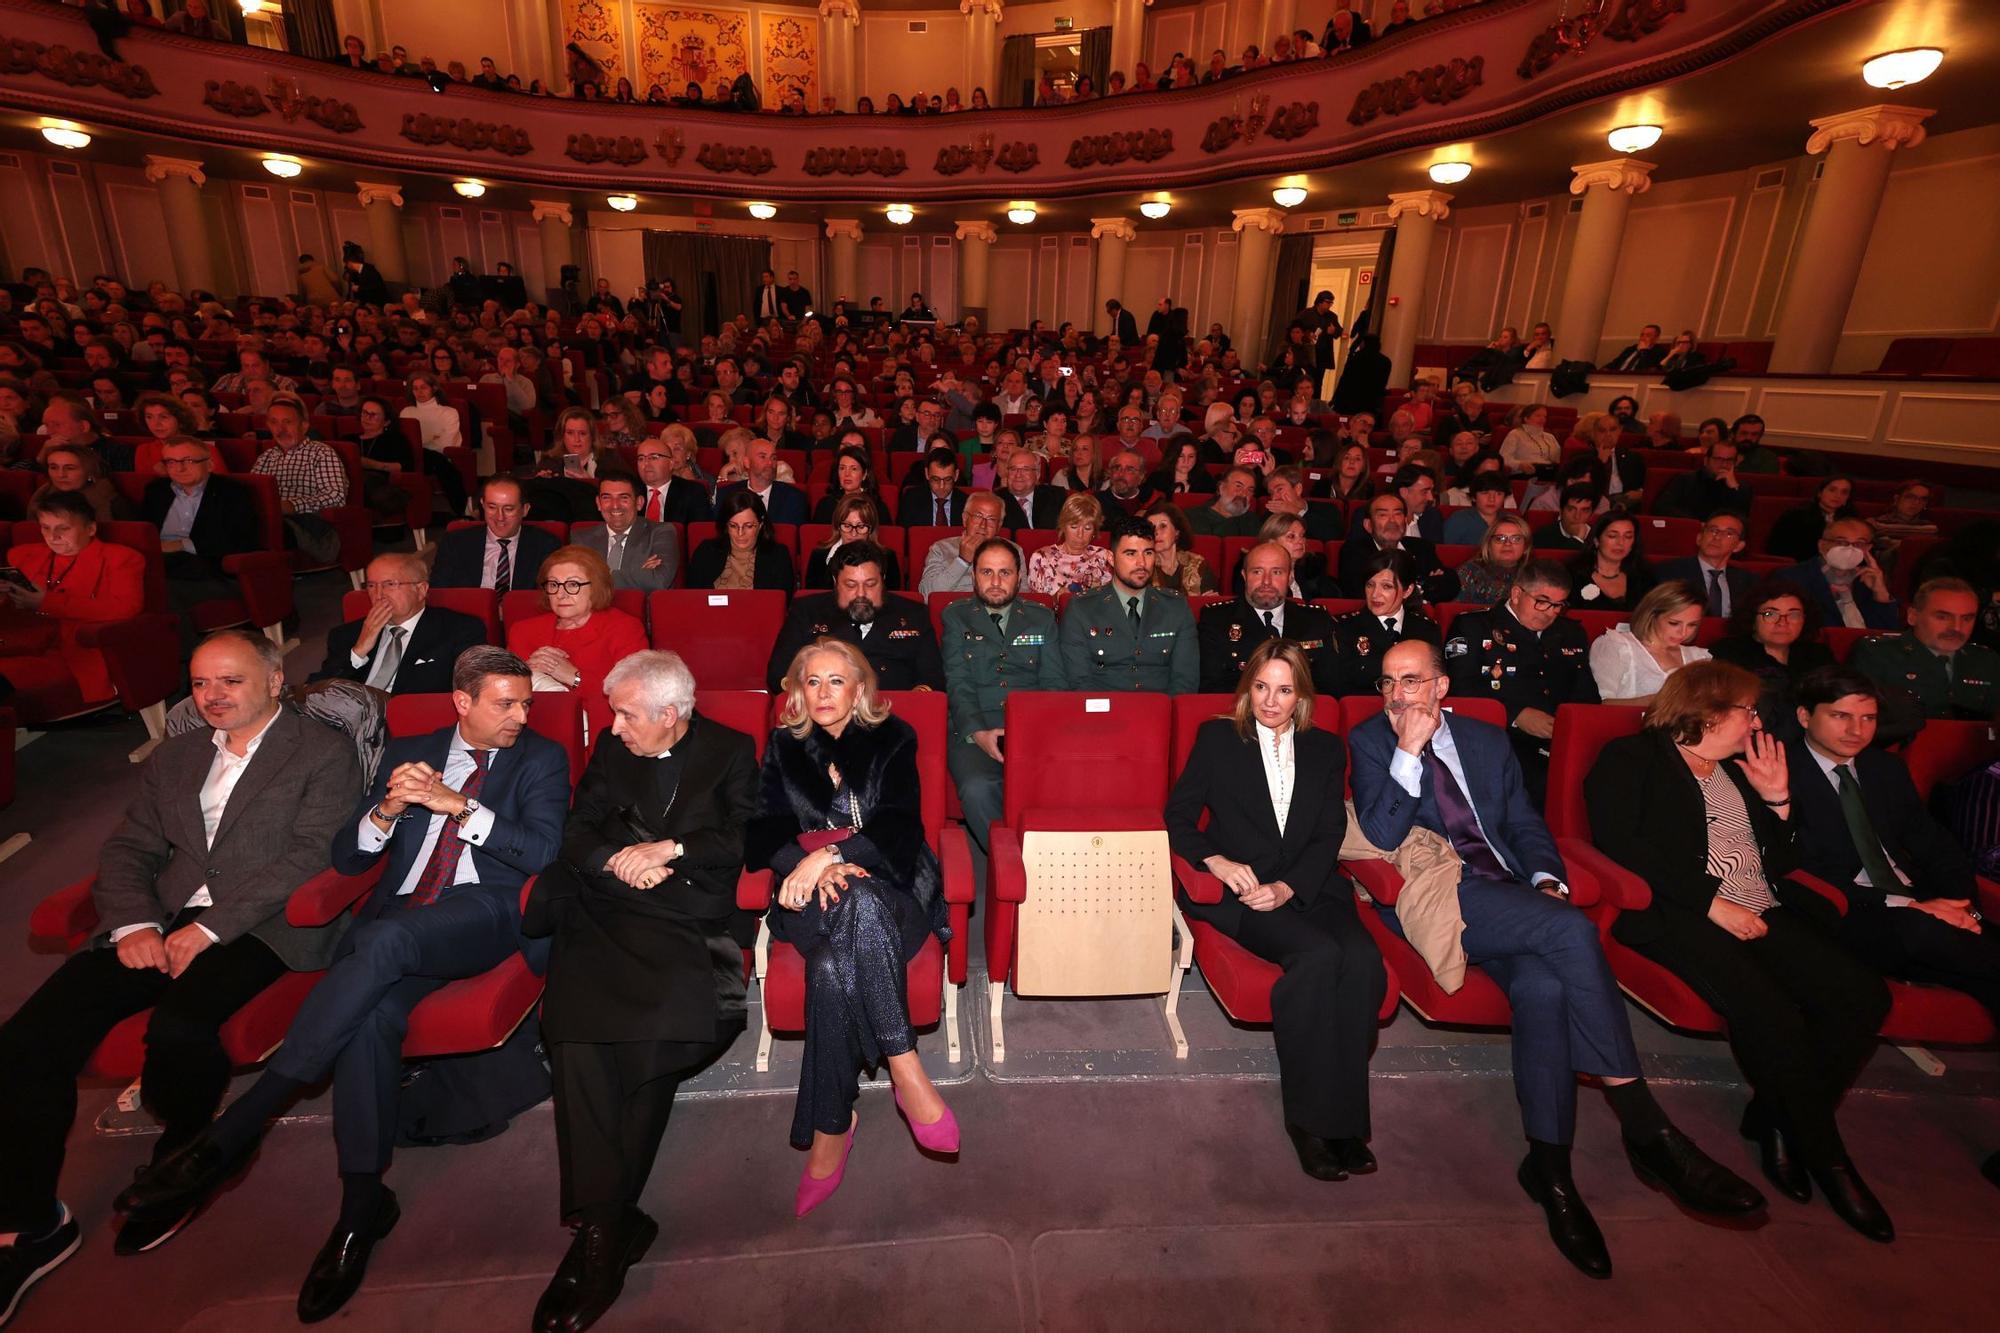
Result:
[312, 552, 486, 695]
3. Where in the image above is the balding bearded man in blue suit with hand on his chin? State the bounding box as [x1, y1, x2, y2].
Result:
[1348, 638, 1764, 1277]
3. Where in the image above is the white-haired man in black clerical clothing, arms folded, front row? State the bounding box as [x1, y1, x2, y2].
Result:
[522, 650, 758, 1329]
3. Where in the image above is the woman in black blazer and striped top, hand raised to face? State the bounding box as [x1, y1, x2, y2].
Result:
[1584, 660, 1896, 1241]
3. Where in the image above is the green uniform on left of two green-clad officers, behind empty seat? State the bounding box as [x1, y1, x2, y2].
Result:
[940, 596, 1066, 883]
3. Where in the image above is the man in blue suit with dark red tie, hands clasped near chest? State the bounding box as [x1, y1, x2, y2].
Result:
[118, 644, 570, 1323]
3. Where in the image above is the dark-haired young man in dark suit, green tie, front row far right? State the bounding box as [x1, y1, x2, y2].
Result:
[1786, 667, 2000, 1019]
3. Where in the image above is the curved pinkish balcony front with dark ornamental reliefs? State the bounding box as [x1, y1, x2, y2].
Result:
[0, 0, 1852, 202]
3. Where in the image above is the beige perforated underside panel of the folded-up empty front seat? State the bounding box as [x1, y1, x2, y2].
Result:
[1014, 829, 1174, 997]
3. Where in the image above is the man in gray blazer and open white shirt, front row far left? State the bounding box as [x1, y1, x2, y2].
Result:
[0, 630, 362, 1288]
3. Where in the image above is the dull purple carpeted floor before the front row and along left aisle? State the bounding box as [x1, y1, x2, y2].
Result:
[0, 564, 2000, 1333]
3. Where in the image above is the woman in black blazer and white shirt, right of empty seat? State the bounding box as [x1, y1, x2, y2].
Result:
[1166, 638, 1384, 1181]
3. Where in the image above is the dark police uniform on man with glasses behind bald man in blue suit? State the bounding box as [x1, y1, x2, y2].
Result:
[1444, 606, 1602, 809]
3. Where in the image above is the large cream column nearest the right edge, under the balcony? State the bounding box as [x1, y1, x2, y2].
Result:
[1770, 106, 1944, 374]
